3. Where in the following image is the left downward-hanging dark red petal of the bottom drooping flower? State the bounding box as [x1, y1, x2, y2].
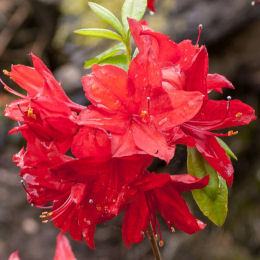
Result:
[122, 193, 150, 247]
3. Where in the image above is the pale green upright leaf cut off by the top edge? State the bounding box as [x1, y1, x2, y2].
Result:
[121, 0, 147, 33]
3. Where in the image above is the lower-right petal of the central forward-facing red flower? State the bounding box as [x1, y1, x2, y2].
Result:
[132, 123, 175, 163]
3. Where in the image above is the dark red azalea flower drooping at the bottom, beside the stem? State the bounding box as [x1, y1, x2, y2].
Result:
[122, 173, 209, 247]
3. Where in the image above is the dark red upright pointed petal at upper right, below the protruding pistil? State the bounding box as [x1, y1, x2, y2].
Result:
[185, 47, 208, 97]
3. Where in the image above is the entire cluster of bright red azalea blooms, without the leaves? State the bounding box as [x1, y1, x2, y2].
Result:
[4, 19, 255, 248]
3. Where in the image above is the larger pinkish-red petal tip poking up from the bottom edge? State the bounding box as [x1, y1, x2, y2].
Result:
[54, 233, 76, 260]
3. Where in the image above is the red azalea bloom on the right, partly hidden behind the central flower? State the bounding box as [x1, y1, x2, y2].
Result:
[129, 19, 255, 185]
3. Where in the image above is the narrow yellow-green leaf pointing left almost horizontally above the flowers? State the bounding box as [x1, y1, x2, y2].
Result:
[75, 28, 123, 42]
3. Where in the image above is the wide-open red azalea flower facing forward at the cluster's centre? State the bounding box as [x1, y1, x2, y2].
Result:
[79, 37, 203, 162]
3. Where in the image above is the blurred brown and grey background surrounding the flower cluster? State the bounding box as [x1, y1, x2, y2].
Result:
[0, 0, 260, 260]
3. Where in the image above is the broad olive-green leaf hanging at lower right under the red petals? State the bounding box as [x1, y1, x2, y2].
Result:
[187, 148, 228, 226]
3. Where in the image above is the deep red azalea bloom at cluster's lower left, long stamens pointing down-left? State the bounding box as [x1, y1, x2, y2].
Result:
[14, 127, 151, 248]
